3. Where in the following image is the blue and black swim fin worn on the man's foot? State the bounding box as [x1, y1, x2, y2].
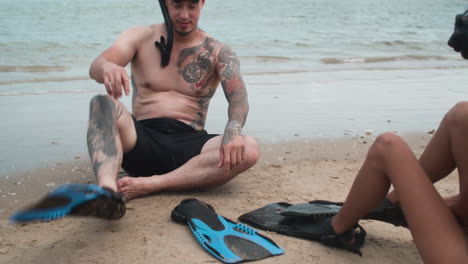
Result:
[9, 183, 126, 223]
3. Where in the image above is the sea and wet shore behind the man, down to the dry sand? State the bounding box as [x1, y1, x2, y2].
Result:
[0, 0, 468, 174]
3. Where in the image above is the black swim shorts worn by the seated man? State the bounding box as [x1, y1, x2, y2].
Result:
[122, 117, 218, 176]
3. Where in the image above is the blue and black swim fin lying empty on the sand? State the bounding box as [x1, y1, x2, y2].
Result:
[171, 199, 284, 263]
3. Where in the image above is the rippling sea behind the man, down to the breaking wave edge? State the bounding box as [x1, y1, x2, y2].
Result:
[0, 0, 468, 87]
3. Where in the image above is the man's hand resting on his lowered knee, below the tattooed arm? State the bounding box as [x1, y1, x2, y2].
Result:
[218, 121, 245, 173]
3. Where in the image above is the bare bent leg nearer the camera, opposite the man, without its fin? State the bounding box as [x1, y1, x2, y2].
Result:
[332, 133, 468, 263]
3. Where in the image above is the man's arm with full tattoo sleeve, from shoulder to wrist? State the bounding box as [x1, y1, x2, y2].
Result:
[218, 46, 249, 145]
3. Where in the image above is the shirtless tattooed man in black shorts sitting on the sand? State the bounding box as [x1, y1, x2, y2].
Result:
[87, 0, 258, 198]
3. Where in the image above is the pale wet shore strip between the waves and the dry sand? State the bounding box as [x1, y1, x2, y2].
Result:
[0, 65, 466, 176]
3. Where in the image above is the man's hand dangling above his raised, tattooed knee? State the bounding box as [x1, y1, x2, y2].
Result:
[103, 62, 130, 99]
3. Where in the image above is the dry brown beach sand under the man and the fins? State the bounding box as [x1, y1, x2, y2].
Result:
[0, 133, 458, 264]
